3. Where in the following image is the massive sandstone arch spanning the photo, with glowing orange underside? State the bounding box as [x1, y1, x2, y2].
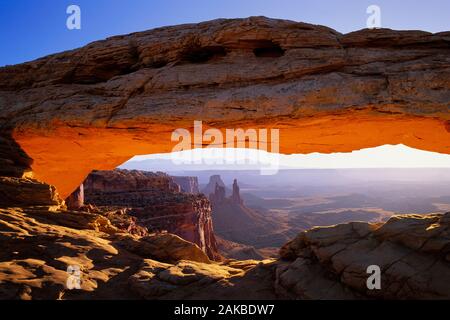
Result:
[0, 17, 450, 198]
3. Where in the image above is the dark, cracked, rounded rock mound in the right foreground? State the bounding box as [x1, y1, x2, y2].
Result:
[276, 213, 450, 299]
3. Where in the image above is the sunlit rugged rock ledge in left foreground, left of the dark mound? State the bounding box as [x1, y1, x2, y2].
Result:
[0, 207, 275, 300]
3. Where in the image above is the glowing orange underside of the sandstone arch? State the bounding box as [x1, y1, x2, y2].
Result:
[11, 115, 450, 197]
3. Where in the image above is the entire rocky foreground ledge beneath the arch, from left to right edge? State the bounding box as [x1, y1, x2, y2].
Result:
[0, 201, 450, 300]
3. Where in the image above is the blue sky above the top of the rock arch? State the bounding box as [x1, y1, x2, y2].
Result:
[0, 0, 450, 66]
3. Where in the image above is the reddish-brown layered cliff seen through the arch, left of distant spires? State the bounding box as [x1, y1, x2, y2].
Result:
[83, 169, 220, 260]
